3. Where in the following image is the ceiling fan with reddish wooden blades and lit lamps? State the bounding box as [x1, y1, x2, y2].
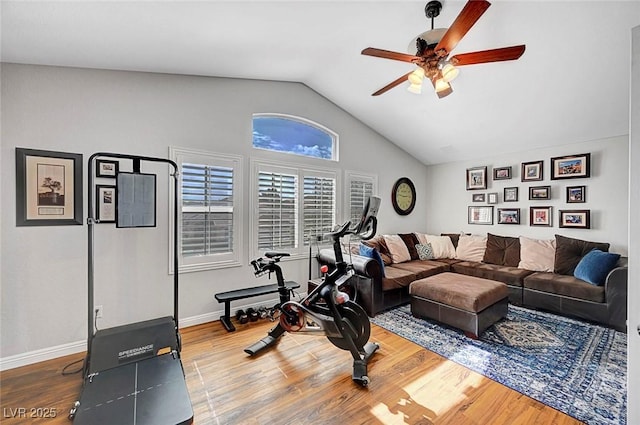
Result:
[362, 0, 525, 98]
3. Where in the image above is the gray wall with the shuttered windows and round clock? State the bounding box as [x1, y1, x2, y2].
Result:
[0, 64, 428, 367]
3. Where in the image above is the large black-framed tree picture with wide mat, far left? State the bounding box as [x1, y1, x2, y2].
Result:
[16, 148, 83, 226]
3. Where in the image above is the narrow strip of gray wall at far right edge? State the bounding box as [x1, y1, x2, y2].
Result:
[627, 26, 640, 424]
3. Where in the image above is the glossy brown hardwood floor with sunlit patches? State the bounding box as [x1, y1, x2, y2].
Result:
[0, 321, 581, 425]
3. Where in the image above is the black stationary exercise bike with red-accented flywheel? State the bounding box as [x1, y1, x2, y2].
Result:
[244, 197, 380, 387]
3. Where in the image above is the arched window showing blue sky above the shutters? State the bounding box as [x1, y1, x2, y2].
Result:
[253, 113, 338, 161]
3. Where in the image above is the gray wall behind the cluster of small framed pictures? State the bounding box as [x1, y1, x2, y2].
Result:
[425, 136, 629, 255]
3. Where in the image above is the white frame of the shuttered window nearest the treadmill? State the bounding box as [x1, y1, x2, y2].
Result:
[169, 146, 244, 274]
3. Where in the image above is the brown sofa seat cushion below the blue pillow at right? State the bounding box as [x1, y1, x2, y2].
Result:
[524, 272, 605, 303]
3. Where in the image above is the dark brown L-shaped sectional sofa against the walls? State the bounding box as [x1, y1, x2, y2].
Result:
[318, 234, 627, 332]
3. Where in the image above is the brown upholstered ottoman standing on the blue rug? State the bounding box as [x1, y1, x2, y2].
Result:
[409, 273, 509, 339]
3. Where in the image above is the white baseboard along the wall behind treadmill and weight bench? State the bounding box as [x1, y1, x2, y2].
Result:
[0, 298, 278, 371]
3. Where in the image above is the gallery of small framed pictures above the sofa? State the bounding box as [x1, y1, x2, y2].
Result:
[466, 153, 592, 229]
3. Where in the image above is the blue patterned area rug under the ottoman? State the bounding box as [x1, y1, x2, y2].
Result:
[372, 305, 627, 425]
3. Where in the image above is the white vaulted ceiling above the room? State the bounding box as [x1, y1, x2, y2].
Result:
[0, 0, 640, 164]
